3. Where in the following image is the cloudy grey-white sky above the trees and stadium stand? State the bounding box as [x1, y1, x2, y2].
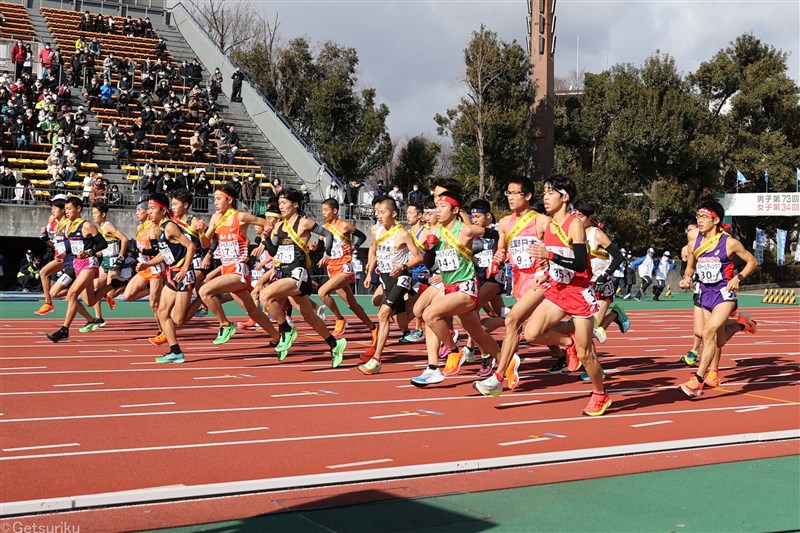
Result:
[256, 0, 800, 139]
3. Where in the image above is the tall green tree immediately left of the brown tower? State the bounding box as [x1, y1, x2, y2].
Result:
[434, 25, 533, 201]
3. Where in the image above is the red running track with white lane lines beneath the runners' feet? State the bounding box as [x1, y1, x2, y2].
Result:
[0, 308, 800, 514]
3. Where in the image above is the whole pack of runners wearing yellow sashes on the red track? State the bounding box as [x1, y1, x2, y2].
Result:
[29, 175, 757, 416]
